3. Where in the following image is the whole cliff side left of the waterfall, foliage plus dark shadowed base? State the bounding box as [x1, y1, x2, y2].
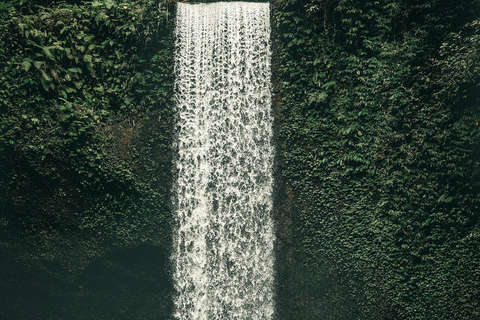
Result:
[0, 0, 173, 319]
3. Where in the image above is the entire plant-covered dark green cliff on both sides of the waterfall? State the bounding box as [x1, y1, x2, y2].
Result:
[0, 0, 480, 320]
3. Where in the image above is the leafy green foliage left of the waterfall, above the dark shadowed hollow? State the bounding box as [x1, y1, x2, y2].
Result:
[0, 0, 173, 276]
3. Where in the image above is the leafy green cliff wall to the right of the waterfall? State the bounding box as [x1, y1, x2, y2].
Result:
[272, 0, 480, 320]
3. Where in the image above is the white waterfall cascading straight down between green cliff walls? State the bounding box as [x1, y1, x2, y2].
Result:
[173, 2, 274, 320]
